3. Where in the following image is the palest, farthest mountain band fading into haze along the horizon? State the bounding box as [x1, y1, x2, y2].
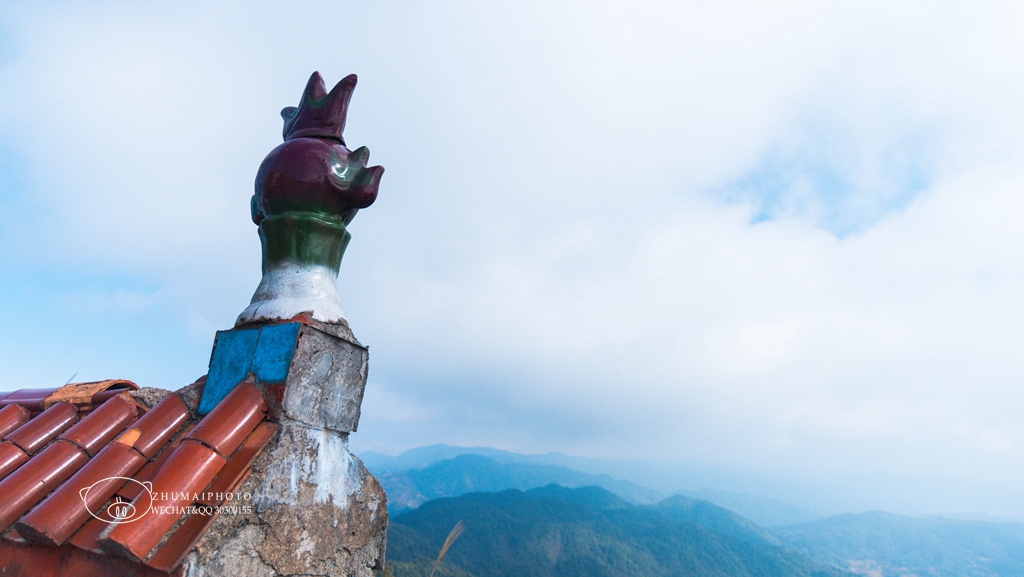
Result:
[360, 445, 1024, 525]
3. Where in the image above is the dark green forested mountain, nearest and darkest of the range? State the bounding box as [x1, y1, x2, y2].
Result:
[388, 486, 849, 577]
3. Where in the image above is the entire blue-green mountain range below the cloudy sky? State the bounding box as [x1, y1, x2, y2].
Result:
[372, 445, 1024, 577]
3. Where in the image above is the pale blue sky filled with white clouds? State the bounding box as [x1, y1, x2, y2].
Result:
[0, 1, 1024, 517]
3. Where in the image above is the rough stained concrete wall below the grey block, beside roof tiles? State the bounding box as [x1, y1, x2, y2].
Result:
[184, 419, 388, 577]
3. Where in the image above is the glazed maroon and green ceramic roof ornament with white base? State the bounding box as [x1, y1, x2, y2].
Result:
[236, 72, 384, 326]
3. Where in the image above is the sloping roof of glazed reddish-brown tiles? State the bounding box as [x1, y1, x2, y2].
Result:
[0, 377, 276, 577]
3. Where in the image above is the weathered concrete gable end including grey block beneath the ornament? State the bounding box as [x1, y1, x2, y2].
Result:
[183, 322, 388, 577]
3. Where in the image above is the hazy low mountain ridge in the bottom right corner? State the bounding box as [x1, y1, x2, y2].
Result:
[772, 512, 1024, 577]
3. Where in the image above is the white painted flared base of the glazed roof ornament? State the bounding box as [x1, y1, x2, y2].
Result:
[234, 262, 345, 325]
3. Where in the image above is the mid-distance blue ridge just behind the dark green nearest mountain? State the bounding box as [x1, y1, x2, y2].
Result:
[370, 454, 663, 513]
